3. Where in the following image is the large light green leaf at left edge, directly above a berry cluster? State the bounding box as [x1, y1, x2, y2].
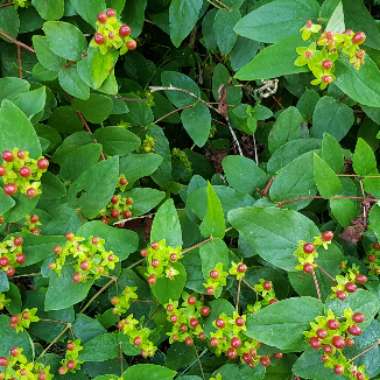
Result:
[0, 100, 41, 158]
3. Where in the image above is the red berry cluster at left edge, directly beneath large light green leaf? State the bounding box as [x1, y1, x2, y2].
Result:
[0, 149, 49, 198]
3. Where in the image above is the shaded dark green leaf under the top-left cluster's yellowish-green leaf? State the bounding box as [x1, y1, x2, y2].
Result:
[73, 94, 113, 124]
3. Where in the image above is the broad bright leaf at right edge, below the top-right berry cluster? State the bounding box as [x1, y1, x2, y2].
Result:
[334, 55, 380, 107]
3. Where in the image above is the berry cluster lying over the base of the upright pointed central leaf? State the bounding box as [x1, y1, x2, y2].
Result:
[140, 240, 183, 285]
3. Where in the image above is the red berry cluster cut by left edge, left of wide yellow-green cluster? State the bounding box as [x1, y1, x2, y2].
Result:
[0, 236, 25, 277]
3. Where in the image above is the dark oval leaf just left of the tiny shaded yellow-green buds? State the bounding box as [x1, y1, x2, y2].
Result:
[94, 127, 141, 156]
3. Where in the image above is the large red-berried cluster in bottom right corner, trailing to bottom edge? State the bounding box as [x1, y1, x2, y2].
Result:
[305, 308, 367, 380]
